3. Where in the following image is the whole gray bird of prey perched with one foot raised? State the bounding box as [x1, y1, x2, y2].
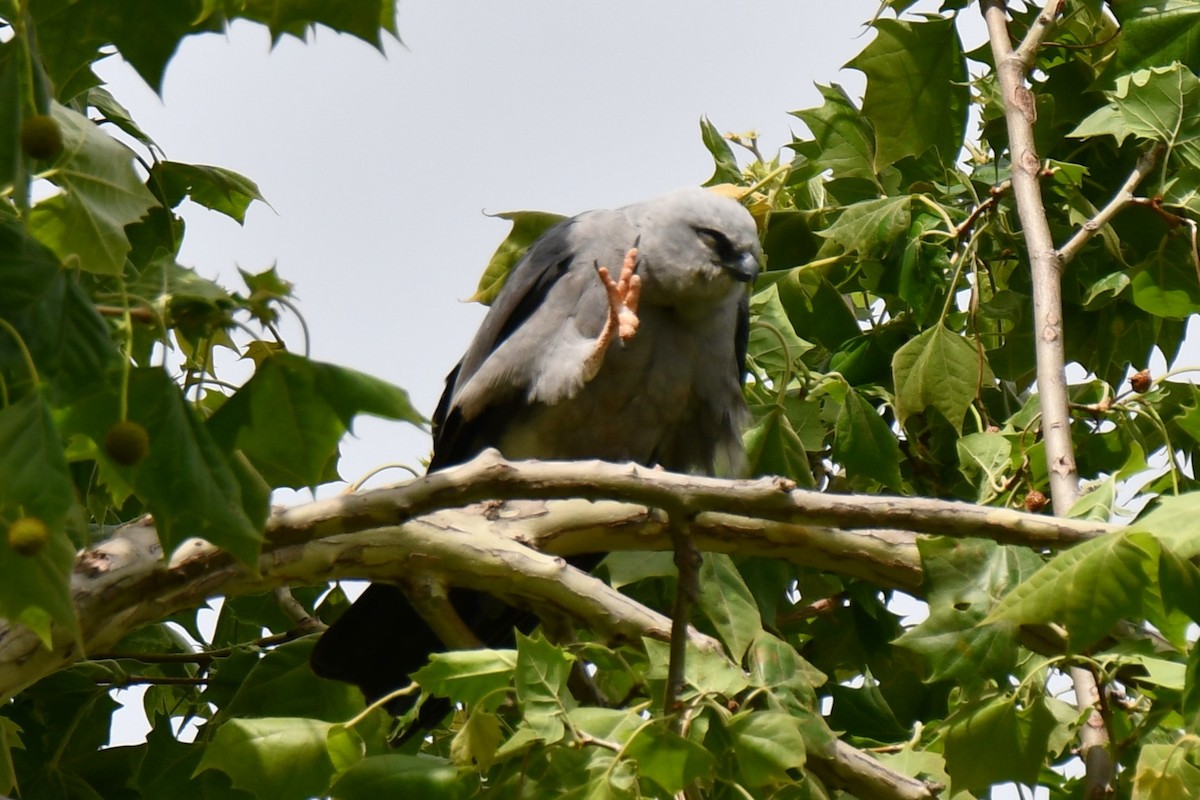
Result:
[312, 188, 761, 727]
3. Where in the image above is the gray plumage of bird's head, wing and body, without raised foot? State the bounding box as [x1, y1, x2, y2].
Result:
[434, 188, 761, 473]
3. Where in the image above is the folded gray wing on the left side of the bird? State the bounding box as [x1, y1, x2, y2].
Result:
[430, 211, 637, 470]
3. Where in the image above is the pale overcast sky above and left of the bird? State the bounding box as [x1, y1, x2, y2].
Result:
[93, 0, 979, 494]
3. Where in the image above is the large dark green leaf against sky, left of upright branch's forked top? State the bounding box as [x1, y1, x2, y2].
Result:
[846, 17, 971, 173]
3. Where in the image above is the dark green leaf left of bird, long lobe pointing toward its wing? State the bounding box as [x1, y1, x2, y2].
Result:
[208, 353, 425, 488]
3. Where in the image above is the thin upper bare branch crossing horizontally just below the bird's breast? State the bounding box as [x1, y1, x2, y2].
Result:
[266, 451, 1115, 554]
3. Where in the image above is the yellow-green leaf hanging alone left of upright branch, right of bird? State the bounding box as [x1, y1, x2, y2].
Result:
[892, 325, 996, 433]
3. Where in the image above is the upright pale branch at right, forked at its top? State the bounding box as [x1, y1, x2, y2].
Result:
[982, 0, 1114, 800]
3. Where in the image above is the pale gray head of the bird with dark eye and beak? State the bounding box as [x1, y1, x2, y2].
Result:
[626, 188, 762, 311]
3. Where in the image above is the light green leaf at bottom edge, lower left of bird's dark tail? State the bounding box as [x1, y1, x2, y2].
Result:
[196, 717, 362, 800]
